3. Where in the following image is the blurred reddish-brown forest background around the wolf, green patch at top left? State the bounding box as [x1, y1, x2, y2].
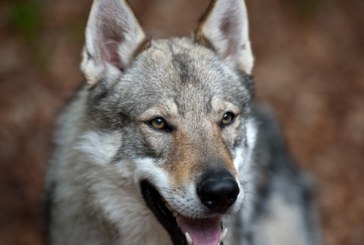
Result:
[0, 0, 364, 245]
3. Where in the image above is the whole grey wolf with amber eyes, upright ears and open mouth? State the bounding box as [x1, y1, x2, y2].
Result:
[46, 0, 319, 245]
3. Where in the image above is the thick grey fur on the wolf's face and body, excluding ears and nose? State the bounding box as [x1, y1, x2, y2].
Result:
[47, 0, 319, 245]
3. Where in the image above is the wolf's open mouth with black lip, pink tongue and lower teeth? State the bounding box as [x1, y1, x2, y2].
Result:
[140, 181, 227, 245]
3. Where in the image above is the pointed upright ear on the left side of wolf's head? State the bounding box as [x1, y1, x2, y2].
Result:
[81, 0, 146, 85]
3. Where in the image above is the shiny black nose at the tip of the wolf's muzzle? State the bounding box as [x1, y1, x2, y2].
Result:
[197, 170, 239, 212]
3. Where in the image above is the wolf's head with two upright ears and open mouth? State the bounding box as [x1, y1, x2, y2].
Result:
[81, 0, 255, 245]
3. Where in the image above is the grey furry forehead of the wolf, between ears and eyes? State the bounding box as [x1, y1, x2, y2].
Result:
[120, 38, 245, 115]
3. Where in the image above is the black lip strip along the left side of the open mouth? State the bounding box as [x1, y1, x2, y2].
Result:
[140, 180, 187, 245]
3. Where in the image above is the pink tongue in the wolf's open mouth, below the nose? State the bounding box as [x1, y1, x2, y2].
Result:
[176, 215, 221, 245]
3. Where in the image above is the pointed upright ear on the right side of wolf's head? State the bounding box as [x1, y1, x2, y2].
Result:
[196, 0, 254, 75]
